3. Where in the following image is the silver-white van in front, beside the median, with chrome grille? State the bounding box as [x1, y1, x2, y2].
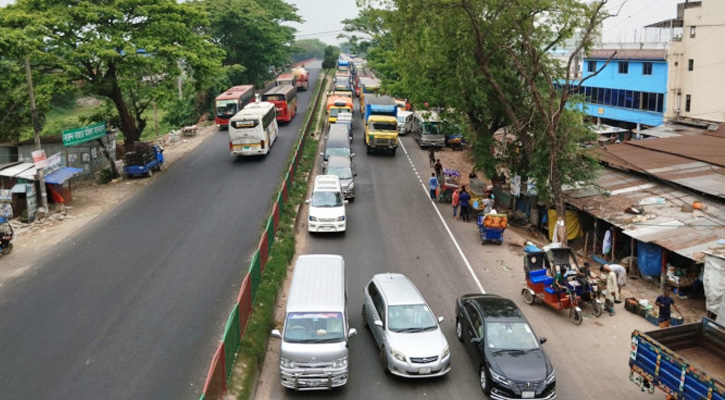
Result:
[272, 254, 357, 390]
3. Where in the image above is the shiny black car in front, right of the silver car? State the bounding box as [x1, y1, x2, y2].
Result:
[456, 294, 556, 400]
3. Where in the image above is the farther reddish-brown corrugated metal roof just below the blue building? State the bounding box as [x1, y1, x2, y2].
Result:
[596, 145, 725, 198]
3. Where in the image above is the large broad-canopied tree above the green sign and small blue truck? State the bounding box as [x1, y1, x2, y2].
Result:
[0, 0, 223, 146]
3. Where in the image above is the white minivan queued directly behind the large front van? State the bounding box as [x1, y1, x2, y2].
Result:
[306, 175, 347, 232]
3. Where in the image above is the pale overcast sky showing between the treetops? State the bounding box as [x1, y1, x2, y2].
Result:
[0, 0, 680, 44]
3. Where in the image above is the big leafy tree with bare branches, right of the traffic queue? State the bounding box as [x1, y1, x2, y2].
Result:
[362, 0, 609, 243]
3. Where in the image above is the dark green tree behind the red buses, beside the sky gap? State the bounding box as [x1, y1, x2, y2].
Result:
[205, 0, 302, 85]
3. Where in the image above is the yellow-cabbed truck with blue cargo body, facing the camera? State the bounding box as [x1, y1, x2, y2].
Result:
[363, 93, 398, 155]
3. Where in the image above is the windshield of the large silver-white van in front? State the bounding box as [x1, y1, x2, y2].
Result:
[284, 312, 344, 343]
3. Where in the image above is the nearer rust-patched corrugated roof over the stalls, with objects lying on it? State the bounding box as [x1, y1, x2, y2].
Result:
[565, 168, 725, 262]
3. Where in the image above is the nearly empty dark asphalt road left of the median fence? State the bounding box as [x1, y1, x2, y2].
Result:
[0, 65, 319, 400]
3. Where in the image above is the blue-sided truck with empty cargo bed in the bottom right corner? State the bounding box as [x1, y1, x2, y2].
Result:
[629, 318, 725, 400]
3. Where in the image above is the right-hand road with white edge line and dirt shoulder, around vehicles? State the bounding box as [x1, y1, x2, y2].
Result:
[257, 97, 658, 400]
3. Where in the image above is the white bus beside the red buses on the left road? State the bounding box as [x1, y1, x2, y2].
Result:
[229, 101, 279, 156]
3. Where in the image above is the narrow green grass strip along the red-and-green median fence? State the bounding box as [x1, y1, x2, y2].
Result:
[227, 74, 322, 400]
